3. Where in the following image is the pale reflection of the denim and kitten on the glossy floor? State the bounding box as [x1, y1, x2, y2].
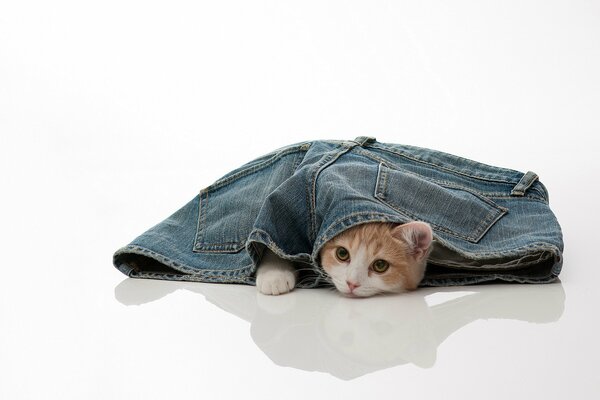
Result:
[115, 279, 565, 379]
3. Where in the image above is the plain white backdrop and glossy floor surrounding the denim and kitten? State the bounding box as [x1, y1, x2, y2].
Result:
[0, 0, 600, 399]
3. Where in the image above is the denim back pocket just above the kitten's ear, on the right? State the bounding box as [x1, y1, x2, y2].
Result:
[375, 163, 508, 243]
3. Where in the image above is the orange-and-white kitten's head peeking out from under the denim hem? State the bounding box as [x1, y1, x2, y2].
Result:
[319, 222, 432, 297]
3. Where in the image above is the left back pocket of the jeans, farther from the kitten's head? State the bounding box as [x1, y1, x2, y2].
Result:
[193, 143, 310, 253]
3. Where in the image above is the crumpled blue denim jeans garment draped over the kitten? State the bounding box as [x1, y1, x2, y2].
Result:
[113, 137, 563, 287]
